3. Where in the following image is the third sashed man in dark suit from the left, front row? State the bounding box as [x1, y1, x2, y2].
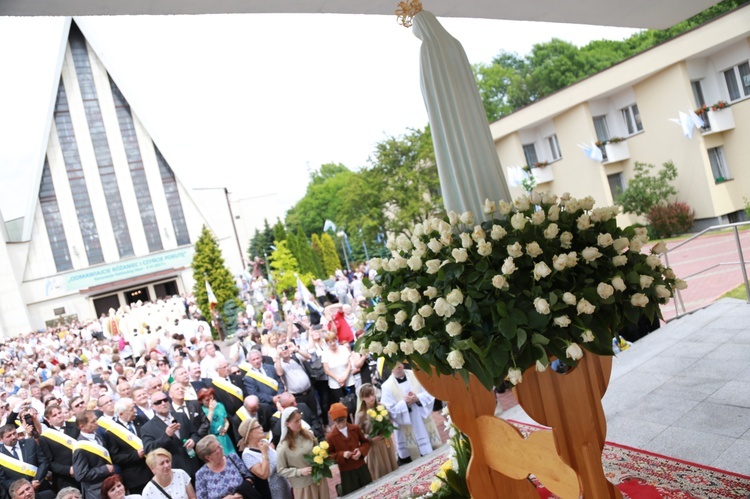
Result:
[73, 411, 115, 499]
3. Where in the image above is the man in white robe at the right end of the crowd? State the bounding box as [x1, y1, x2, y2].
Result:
[381, 370, 442, 460]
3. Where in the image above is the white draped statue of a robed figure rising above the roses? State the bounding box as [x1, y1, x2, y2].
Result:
[413, 10, 510, 219]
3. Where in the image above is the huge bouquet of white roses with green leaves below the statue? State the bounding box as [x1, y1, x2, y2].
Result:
[357, 192, 685, 389]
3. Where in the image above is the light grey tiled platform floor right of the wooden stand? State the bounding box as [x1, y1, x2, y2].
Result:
[503, 299, 750, 476]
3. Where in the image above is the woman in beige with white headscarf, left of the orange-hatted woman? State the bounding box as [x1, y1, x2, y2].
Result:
[276, 407, 329, 499]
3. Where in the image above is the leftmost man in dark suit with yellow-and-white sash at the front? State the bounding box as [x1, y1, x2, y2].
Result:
[0, 424, 54, 499]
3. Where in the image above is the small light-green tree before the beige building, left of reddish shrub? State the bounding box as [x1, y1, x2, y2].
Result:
[615, 161, 677, 215]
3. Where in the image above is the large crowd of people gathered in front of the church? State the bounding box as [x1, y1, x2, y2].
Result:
[0, 268, 442, 499]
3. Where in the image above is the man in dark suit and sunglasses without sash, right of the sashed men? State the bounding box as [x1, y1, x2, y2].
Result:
[141, 392, 201, 476]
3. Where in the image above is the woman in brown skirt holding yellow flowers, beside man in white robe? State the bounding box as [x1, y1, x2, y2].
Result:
[354, 383, 398, 481]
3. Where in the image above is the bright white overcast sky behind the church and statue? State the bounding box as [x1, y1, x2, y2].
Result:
[0, 14, 635, 231]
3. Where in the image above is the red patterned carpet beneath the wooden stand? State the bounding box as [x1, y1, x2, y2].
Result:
[360, 421, 750, 499]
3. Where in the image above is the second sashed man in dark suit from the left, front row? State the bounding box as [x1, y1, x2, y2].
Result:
[39, 404, 81, 490]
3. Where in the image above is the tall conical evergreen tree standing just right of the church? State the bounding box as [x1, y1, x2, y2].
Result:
[191, 225, 242, 340]
